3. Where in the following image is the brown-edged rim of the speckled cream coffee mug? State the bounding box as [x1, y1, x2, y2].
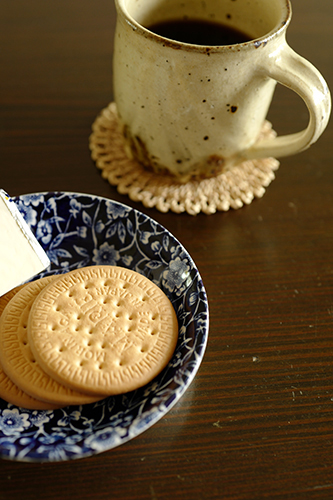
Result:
[115, 0, 292, 53]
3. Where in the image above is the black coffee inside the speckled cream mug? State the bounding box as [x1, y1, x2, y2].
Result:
[148, 19, 251, 45]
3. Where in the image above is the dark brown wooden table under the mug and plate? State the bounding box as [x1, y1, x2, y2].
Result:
[0, 0, 333, 500]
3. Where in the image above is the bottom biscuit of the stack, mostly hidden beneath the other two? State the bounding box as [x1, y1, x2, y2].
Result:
[0, 285, 58, 410]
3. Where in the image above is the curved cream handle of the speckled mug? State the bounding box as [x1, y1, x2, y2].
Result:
[242, 42, 331, 160]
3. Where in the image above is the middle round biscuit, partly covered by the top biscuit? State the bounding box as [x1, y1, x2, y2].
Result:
[0, 276, 102, 409]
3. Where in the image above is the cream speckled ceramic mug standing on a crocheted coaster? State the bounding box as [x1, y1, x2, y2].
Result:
[114, 0, 331, 181]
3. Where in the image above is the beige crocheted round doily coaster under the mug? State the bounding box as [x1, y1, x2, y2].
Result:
[89, 103, 279, 215]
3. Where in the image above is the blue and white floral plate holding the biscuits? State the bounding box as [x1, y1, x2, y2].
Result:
[0, 192, 208, 462]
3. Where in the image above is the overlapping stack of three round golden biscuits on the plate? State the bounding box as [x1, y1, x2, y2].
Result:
[0, 266, 178, 410]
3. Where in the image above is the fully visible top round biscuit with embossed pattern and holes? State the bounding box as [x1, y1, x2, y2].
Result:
[28, 266, 178, 396]
